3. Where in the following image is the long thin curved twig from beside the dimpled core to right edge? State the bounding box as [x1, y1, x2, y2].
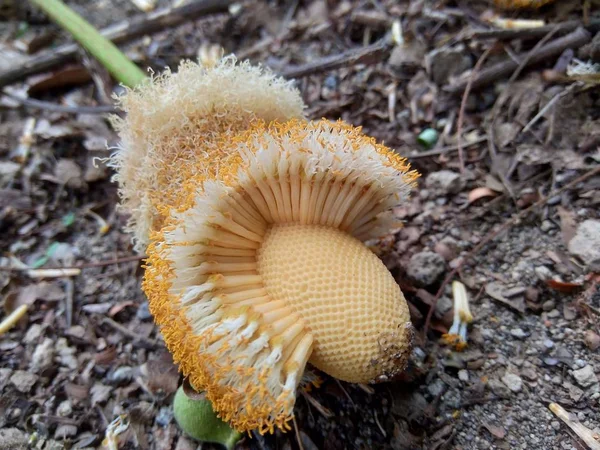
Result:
[423, 167, 600, 340]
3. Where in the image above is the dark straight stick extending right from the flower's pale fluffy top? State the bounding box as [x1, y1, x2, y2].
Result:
[281, 38, 392, 78]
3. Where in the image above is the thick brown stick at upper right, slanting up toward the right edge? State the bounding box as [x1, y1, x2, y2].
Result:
[444, 27, 592, 94]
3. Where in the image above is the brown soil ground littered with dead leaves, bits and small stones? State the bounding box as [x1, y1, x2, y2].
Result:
[0, 0, 600, 450]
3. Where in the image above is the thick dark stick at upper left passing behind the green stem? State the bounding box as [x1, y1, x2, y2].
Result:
[0, 0, 234, 87]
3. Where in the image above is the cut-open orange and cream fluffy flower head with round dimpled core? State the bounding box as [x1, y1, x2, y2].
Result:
[116, 55, 417, 432]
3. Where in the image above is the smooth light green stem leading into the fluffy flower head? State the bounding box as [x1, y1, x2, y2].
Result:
[30, 0, 146, 87]
